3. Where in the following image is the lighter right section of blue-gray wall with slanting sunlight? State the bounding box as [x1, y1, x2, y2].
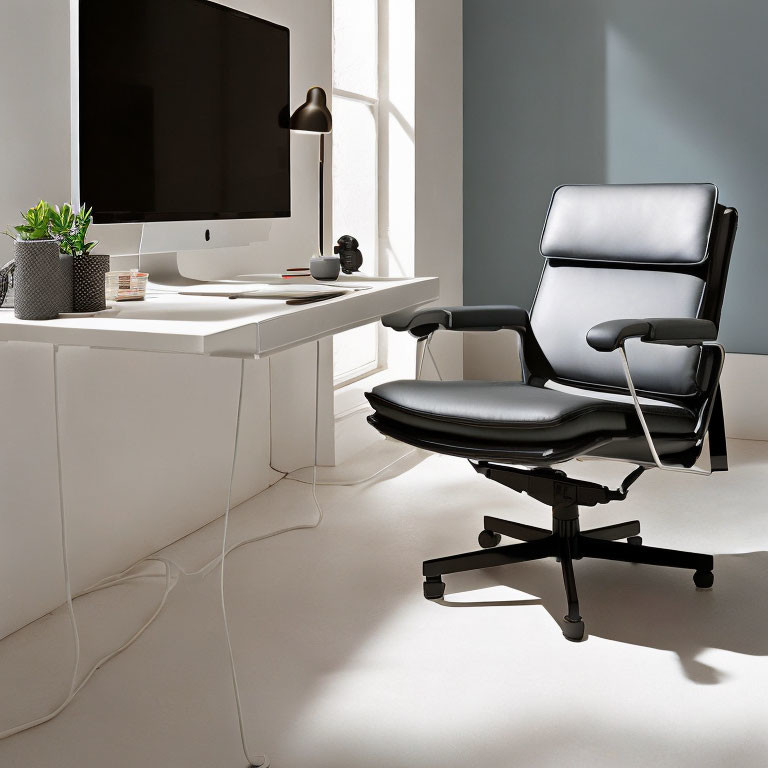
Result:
[604, 0, 768, 354]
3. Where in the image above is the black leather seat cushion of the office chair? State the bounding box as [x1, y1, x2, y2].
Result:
[366, 381, 696, 446]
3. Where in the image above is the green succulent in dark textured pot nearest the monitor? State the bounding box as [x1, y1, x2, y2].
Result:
[51, 203, 109, 312]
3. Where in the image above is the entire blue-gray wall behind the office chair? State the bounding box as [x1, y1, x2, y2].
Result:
[464, 0, 768, 354]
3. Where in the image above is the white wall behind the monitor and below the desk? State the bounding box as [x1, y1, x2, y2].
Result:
[0, 0, 332, 637]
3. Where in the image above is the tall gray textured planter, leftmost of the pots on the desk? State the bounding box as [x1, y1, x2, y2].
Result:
[13, 240, 73, 320]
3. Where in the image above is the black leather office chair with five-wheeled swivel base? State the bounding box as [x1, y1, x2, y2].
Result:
[367, 184, 738, 640]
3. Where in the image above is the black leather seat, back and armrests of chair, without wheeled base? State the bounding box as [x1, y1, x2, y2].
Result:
[368, 184, 735, 466]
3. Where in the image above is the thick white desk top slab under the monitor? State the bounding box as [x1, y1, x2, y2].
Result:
[0, 275, 439, 357]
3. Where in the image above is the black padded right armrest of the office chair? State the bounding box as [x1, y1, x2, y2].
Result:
[587, 317, 717, 352]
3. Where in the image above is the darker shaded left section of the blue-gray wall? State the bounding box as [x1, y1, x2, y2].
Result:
[464, 0, 607, 307]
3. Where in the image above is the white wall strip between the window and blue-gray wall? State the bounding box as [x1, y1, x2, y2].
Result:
[379, 0, 463, 378]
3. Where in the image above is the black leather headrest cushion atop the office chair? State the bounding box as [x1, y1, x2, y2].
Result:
[540, 184, 717, 266]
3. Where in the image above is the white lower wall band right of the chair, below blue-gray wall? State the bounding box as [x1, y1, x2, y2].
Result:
[720, 352, 768, 440]
